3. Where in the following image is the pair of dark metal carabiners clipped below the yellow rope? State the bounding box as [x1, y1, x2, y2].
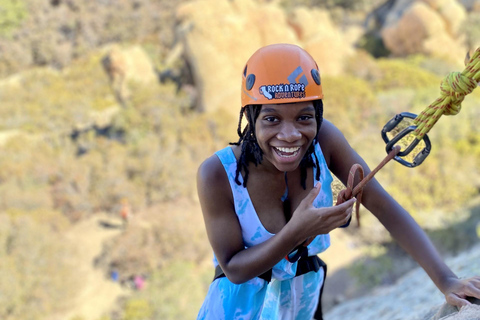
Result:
[382, 112, 432, 168]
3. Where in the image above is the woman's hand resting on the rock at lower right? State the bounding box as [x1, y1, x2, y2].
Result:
[444, 276, 480, 308]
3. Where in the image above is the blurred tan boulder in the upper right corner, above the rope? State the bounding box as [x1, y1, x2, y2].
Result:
[381, 0, 467, 62]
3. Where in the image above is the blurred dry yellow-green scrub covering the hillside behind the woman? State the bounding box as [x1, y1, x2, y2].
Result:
[0, 0, 480, 320]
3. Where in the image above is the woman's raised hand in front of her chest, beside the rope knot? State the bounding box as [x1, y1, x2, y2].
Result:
[290, 183, 356, 239]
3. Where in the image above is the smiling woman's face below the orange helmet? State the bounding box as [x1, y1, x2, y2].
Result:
[255, 101, 317, 172]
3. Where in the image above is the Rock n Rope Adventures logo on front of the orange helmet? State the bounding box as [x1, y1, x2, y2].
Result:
[258, 66, 308, 100]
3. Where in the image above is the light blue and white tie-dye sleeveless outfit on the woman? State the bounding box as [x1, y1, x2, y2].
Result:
[197, 144, 333, 320]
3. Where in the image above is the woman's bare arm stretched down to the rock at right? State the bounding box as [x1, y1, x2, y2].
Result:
[319, 121, 480, 305]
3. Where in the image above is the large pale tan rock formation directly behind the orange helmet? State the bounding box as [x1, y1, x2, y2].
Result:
[177, 0, 354, 116]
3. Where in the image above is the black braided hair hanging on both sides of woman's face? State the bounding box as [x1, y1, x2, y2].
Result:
[230, 100, 323, 189]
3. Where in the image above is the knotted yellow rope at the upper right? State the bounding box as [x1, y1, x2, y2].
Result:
[413, 47, 480, 140]
